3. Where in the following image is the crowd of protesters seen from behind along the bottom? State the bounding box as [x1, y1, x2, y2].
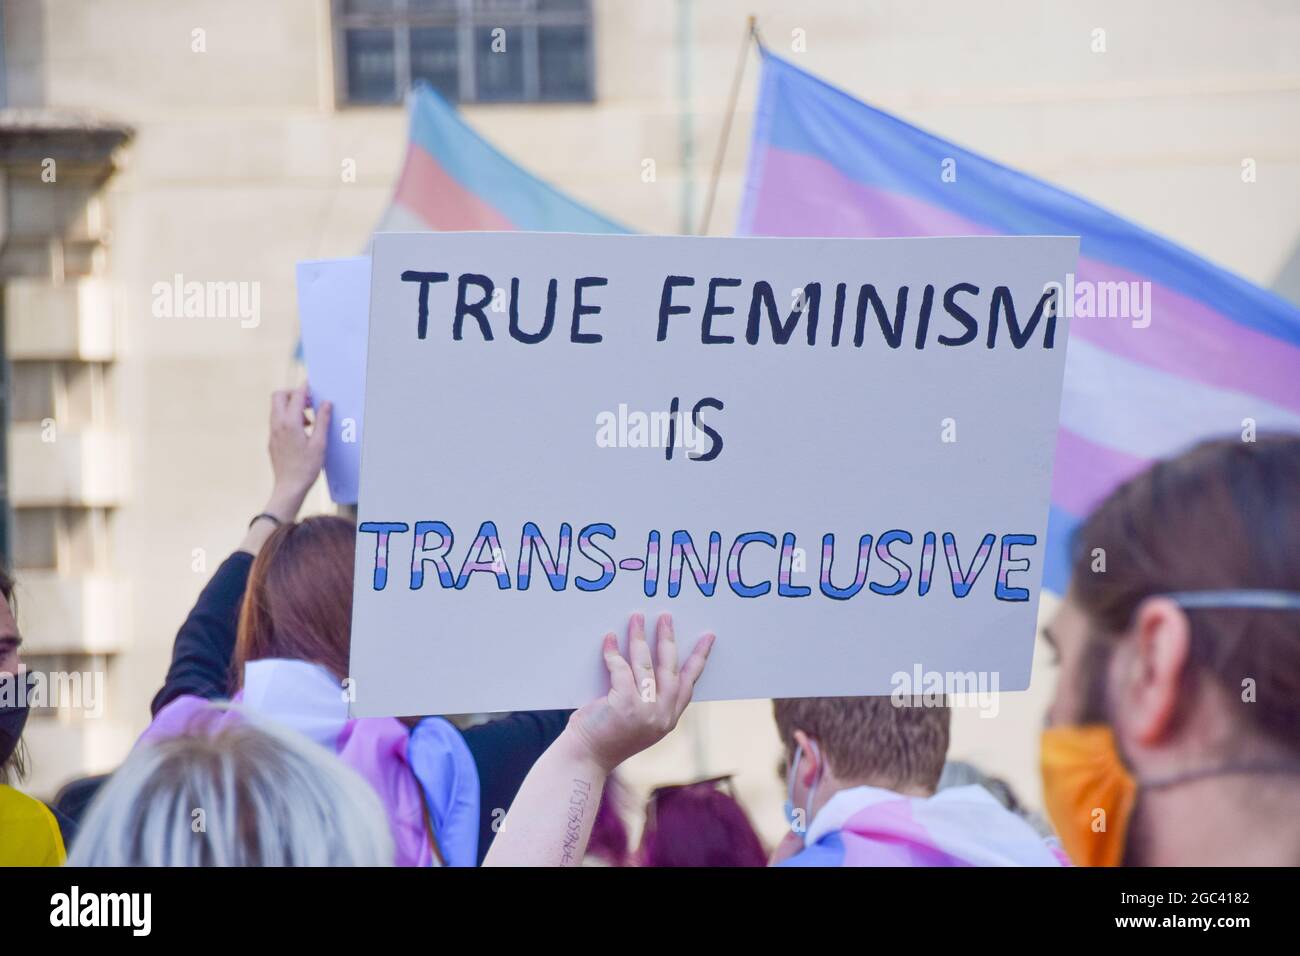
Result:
[0, 388, 1300, 866]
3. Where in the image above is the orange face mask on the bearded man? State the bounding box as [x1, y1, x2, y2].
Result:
[1040, 723, 1138, 866]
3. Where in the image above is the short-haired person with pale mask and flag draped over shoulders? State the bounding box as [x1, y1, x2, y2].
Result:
[772, 697, 1063, 866]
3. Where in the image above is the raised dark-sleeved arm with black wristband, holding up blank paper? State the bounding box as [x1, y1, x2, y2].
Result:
[151, 386, 330, 714]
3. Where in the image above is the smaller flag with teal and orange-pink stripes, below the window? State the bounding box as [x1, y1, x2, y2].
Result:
[374, 83, 628, 233]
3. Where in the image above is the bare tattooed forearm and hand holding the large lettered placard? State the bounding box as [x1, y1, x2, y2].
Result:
[484, 614, 714, 866]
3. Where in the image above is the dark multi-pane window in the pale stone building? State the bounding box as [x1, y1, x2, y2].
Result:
[334, 0, 594, 105]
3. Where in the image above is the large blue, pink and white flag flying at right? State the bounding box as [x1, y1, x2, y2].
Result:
[737, 51, 1300, 592]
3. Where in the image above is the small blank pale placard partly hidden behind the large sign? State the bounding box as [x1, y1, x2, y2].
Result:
[298, 256, 371, 505]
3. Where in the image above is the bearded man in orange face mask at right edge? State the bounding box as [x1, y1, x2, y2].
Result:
[1041, 436, 1300, 866]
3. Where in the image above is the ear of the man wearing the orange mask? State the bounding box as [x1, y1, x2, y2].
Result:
[1115, 597, 1192, 747]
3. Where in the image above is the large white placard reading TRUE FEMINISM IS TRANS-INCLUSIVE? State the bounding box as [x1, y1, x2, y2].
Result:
[351, 233, 1078, 715]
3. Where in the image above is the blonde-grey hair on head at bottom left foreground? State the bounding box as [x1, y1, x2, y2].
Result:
[68, 704, 394, 866]
